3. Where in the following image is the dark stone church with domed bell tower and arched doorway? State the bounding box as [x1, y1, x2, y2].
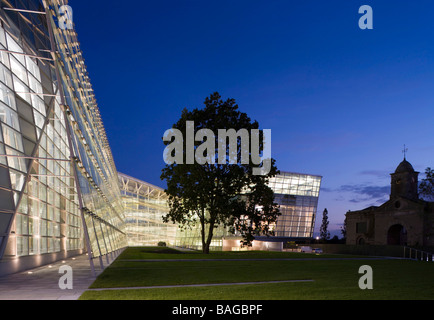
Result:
[346, 157, 434, 246]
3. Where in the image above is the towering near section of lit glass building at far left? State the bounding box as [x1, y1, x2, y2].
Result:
[0, 0, 127, 274]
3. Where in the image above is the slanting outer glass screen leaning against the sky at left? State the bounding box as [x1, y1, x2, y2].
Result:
[45, 0, 127, 257]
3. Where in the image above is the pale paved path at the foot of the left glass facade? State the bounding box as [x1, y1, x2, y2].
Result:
[0, 254, 120, 300]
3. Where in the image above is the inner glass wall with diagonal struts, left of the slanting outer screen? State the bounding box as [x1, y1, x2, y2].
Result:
[0, 1, 83, 257]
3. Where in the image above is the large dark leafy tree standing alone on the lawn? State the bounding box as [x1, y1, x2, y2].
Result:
[161, 92, 280, 253]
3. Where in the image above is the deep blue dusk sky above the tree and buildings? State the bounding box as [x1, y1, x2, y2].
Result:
[69, 0, 434, 236]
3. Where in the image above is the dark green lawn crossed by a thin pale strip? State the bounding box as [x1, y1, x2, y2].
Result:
[80, 247, 434, 300]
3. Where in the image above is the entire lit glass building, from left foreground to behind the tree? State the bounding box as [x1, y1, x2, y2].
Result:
[0, 0, 321, 274]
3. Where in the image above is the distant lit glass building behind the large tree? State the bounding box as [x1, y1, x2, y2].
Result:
[118, 172, 322, 251]
